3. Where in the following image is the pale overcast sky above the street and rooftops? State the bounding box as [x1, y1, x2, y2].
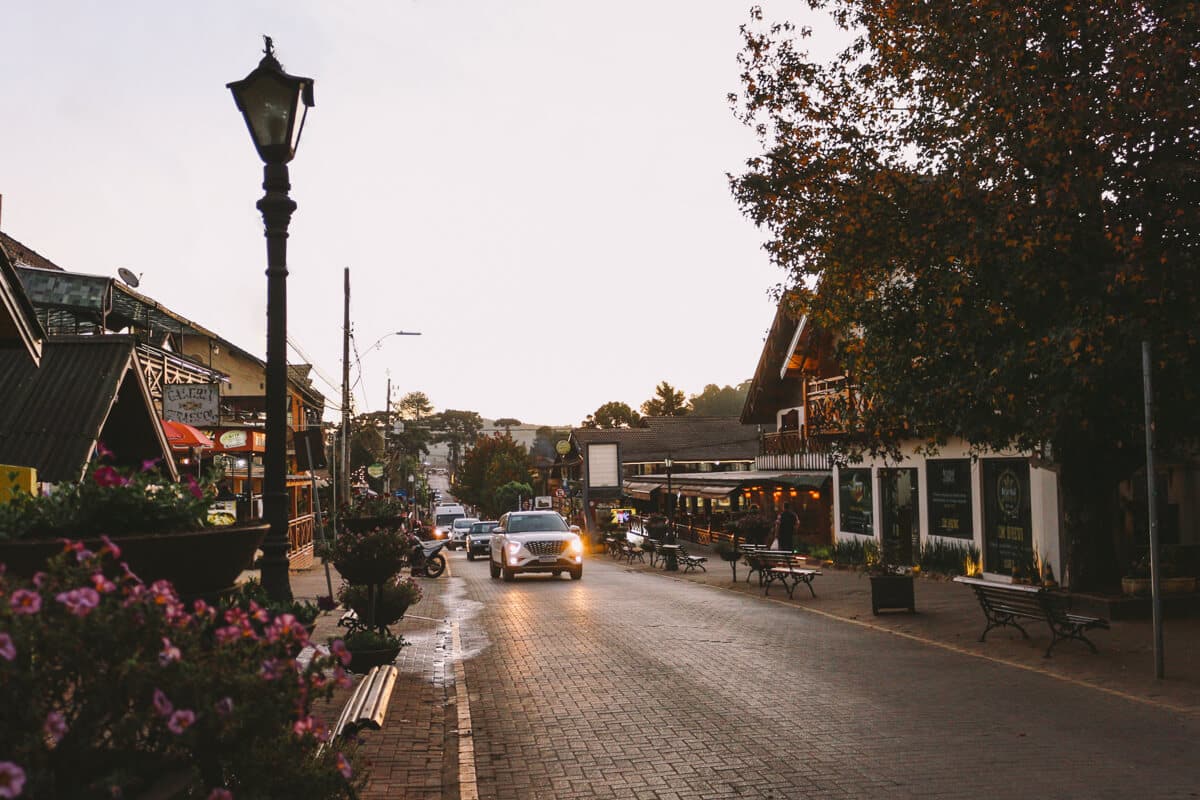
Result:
[0, 0, 840, 426]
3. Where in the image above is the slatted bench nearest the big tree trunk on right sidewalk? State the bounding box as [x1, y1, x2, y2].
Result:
[954, 577, 1109, 658]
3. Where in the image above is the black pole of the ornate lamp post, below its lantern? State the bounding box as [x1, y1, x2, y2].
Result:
[251, 164, 296, 601]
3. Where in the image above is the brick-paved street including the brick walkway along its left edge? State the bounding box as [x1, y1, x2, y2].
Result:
[302, 554, 1200, 800]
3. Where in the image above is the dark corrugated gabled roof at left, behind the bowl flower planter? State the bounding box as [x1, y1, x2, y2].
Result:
[0, 336, 170, 482]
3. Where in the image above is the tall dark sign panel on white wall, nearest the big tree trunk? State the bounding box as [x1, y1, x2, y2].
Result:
[983, 458, 1033, 575]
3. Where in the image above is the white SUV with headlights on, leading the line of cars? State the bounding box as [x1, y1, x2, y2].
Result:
[488, 511, 583, 581]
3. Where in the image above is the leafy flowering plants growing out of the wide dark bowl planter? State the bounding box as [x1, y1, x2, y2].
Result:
[0, 446, 216, 540]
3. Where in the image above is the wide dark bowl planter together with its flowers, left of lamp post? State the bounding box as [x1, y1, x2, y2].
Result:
[0, 447, 268, 599]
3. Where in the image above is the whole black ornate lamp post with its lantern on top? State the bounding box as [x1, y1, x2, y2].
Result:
[227, 36, 313, 600]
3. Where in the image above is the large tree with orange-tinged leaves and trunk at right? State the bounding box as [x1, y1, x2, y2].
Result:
[731, 0, 1200, 588]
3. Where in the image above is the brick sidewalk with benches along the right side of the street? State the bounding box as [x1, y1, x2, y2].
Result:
[614, 542, 1200, 715]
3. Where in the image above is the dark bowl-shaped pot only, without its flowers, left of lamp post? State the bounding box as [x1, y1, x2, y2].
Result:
[0, 523, 270, 597]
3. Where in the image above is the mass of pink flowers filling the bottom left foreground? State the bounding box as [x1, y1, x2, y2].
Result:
[0, 540, 362, 800]
